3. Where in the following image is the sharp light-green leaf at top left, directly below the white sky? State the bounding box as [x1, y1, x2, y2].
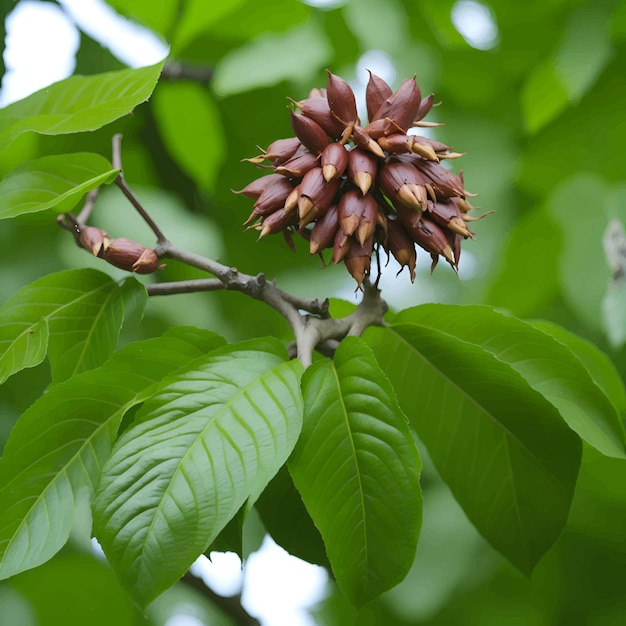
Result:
[0, 62, 163, 152]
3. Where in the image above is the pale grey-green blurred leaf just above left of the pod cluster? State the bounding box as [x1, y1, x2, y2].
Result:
[213, 21, 332, 97]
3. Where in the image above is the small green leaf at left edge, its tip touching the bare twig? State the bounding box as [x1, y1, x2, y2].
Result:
[0, 152, 119, 219]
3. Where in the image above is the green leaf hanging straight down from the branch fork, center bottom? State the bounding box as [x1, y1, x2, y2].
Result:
[289, 338, 421, 606]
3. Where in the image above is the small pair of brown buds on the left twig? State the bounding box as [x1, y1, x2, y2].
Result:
[78, 226, 164, 274]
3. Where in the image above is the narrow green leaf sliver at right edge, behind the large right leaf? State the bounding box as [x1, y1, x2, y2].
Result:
[530, 320, 626, 415]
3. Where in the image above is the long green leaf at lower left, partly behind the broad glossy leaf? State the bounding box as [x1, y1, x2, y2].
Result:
[0, 329, 223, 578]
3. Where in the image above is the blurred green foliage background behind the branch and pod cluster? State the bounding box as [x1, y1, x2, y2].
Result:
[0, 0, 626, 626]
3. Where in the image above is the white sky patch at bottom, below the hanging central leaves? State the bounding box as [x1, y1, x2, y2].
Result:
[241, 536, 328, 626]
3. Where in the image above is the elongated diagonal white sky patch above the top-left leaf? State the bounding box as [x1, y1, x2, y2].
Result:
[59, 0, 169, 67]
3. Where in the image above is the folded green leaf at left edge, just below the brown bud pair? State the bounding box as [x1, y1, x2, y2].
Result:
[0, 269, 146, 383]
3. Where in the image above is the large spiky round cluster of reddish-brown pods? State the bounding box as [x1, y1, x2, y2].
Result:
[236, 72, 478, 287]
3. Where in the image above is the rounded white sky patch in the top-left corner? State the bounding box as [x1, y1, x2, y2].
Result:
[0, 0, 80, 106]
